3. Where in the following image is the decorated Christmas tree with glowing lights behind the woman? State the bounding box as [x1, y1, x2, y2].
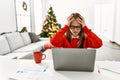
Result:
[40, 6, 61, 38]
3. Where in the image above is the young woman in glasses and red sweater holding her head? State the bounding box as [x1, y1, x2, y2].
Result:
[50, 13, 102, 48]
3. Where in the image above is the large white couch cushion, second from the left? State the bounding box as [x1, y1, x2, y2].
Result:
[6, 32, 24, 51]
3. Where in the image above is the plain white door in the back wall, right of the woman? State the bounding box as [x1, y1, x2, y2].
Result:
[94, 1, 115, 41]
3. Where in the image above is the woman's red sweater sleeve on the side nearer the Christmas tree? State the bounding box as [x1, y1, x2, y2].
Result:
[50, 25, 68, 47]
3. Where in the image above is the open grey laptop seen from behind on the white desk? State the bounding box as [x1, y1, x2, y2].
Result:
[52, 48, 96, 72]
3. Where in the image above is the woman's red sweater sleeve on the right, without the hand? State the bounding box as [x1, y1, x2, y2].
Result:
[83, 26, 102, 48]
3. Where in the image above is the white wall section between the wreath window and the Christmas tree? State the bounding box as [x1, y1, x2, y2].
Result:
[31, 0, 45, 34]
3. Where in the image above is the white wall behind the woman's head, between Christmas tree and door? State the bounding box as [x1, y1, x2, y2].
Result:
[49, 0, 113, 29]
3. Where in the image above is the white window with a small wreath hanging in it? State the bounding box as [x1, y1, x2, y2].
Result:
[15, 0, 31, 32]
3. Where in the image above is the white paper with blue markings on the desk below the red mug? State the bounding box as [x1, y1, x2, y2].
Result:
[9, 63, 48, 80]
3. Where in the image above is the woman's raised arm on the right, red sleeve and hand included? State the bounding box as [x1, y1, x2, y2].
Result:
[77, 15, 102, 48]
